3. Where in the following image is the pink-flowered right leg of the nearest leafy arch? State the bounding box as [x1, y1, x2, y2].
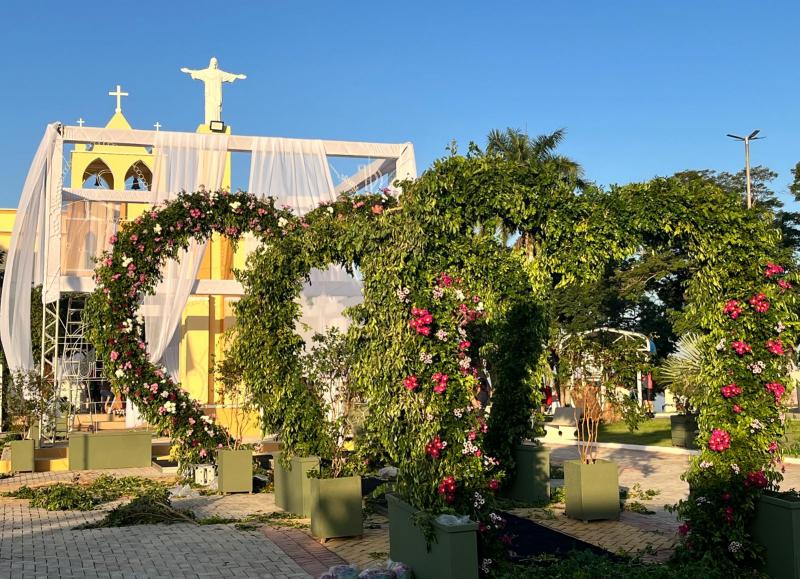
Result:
[677, 263, 796, 565]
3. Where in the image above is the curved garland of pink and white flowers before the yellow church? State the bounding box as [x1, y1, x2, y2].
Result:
[86, 191, 392, 465]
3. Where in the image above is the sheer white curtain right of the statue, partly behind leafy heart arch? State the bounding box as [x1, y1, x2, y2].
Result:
[248, 138, 362, 342]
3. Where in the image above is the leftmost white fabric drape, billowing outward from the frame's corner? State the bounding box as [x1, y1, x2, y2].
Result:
[0, 123, 61, 372]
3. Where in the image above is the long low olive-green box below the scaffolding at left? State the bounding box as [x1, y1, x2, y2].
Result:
[69, 431, 153, 470]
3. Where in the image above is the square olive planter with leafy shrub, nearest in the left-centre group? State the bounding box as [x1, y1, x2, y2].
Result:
[310, 476, 364, 539]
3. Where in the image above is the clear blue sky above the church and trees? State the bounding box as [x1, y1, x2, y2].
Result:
[0, 0, 800, 206]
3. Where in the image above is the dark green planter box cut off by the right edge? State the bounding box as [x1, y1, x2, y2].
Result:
[752, 492, 800, 579]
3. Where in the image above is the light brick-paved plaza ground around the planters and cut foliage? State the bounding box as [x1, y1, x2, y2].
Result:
[0, 445, 800, 579]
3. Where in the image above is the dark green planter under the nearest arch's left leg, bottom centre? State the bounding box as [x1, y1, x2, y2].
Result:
[386, 495, 478, 579]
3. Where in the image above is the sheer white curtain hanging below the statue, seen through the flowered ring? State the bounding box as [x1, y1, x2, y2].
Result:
[125, 132, 228, 427]
